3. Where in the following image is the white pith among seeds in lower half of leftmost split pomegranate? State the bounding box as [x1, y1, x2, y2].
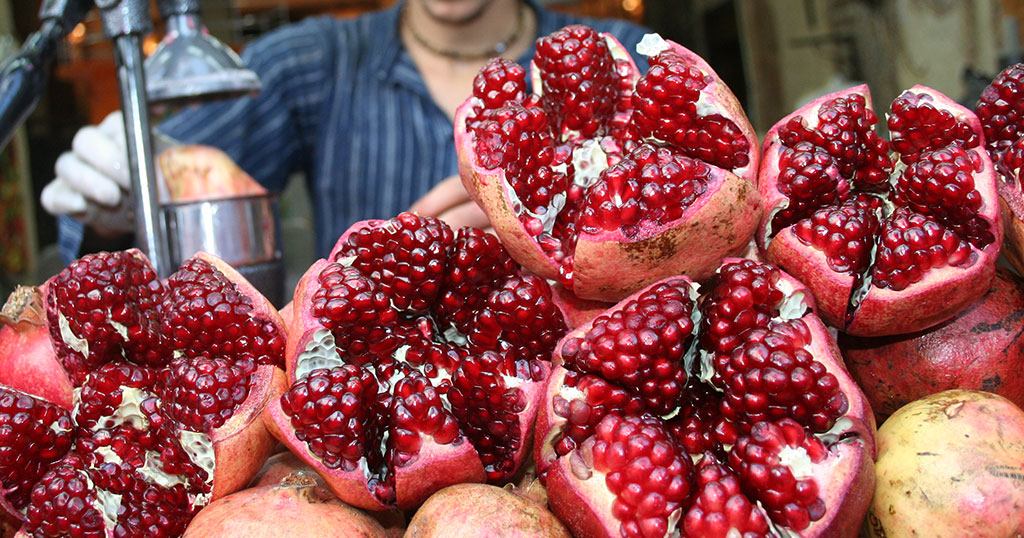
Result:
[72, 379, 216, 518]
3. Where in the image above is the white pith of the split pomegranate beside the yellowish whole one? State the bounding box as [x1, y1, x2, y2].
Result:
[547, 264, 862, 538]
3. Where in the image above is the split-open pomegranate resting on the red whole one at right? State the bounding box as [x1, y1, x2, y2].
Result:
[756, 85, 1002, 336]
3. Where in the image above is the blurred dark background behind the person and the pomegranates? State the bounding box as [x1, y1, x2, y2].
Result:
[0, 0, 1024, 297]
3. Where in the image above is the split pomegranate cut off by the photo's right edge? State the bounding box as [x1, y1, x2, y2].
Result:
[974, 64, 1024, 273]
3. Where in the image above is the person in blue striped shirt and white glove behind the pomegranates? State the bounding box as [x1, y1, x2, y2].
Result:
[42, 0, 647, 260]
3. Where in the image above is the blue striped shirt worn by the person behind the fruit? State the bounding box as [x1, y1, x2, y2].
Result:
[60, 0, 646, 260]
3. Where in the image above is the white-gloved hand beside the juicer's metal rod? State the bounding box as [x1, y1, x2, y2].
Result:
[41, 111, 175, 234]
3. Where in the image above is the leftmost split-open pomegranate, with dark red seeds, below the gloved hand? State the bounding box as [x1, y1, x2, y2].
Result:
[0, 250, 286, 537]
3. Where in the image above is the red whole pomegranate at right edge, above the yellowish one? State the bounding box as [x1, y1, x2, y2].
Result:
[839, 267, 1024, 423]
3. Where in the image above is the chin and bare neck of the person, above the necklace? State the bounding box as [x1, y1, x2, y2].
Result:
[401, 0, 523, 59]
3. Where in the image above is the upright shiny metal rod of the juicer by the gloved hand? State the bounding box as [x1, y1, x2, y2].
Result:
[114, 34, 173, 278]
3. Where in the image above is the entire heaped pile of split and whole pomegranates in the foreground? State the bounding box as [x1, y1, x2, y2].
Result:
[0, 16, 1024, 538]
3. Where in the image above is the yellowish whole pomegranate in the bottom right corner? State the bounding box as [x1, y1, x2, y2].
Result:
[866, 390, 1024, 538]
